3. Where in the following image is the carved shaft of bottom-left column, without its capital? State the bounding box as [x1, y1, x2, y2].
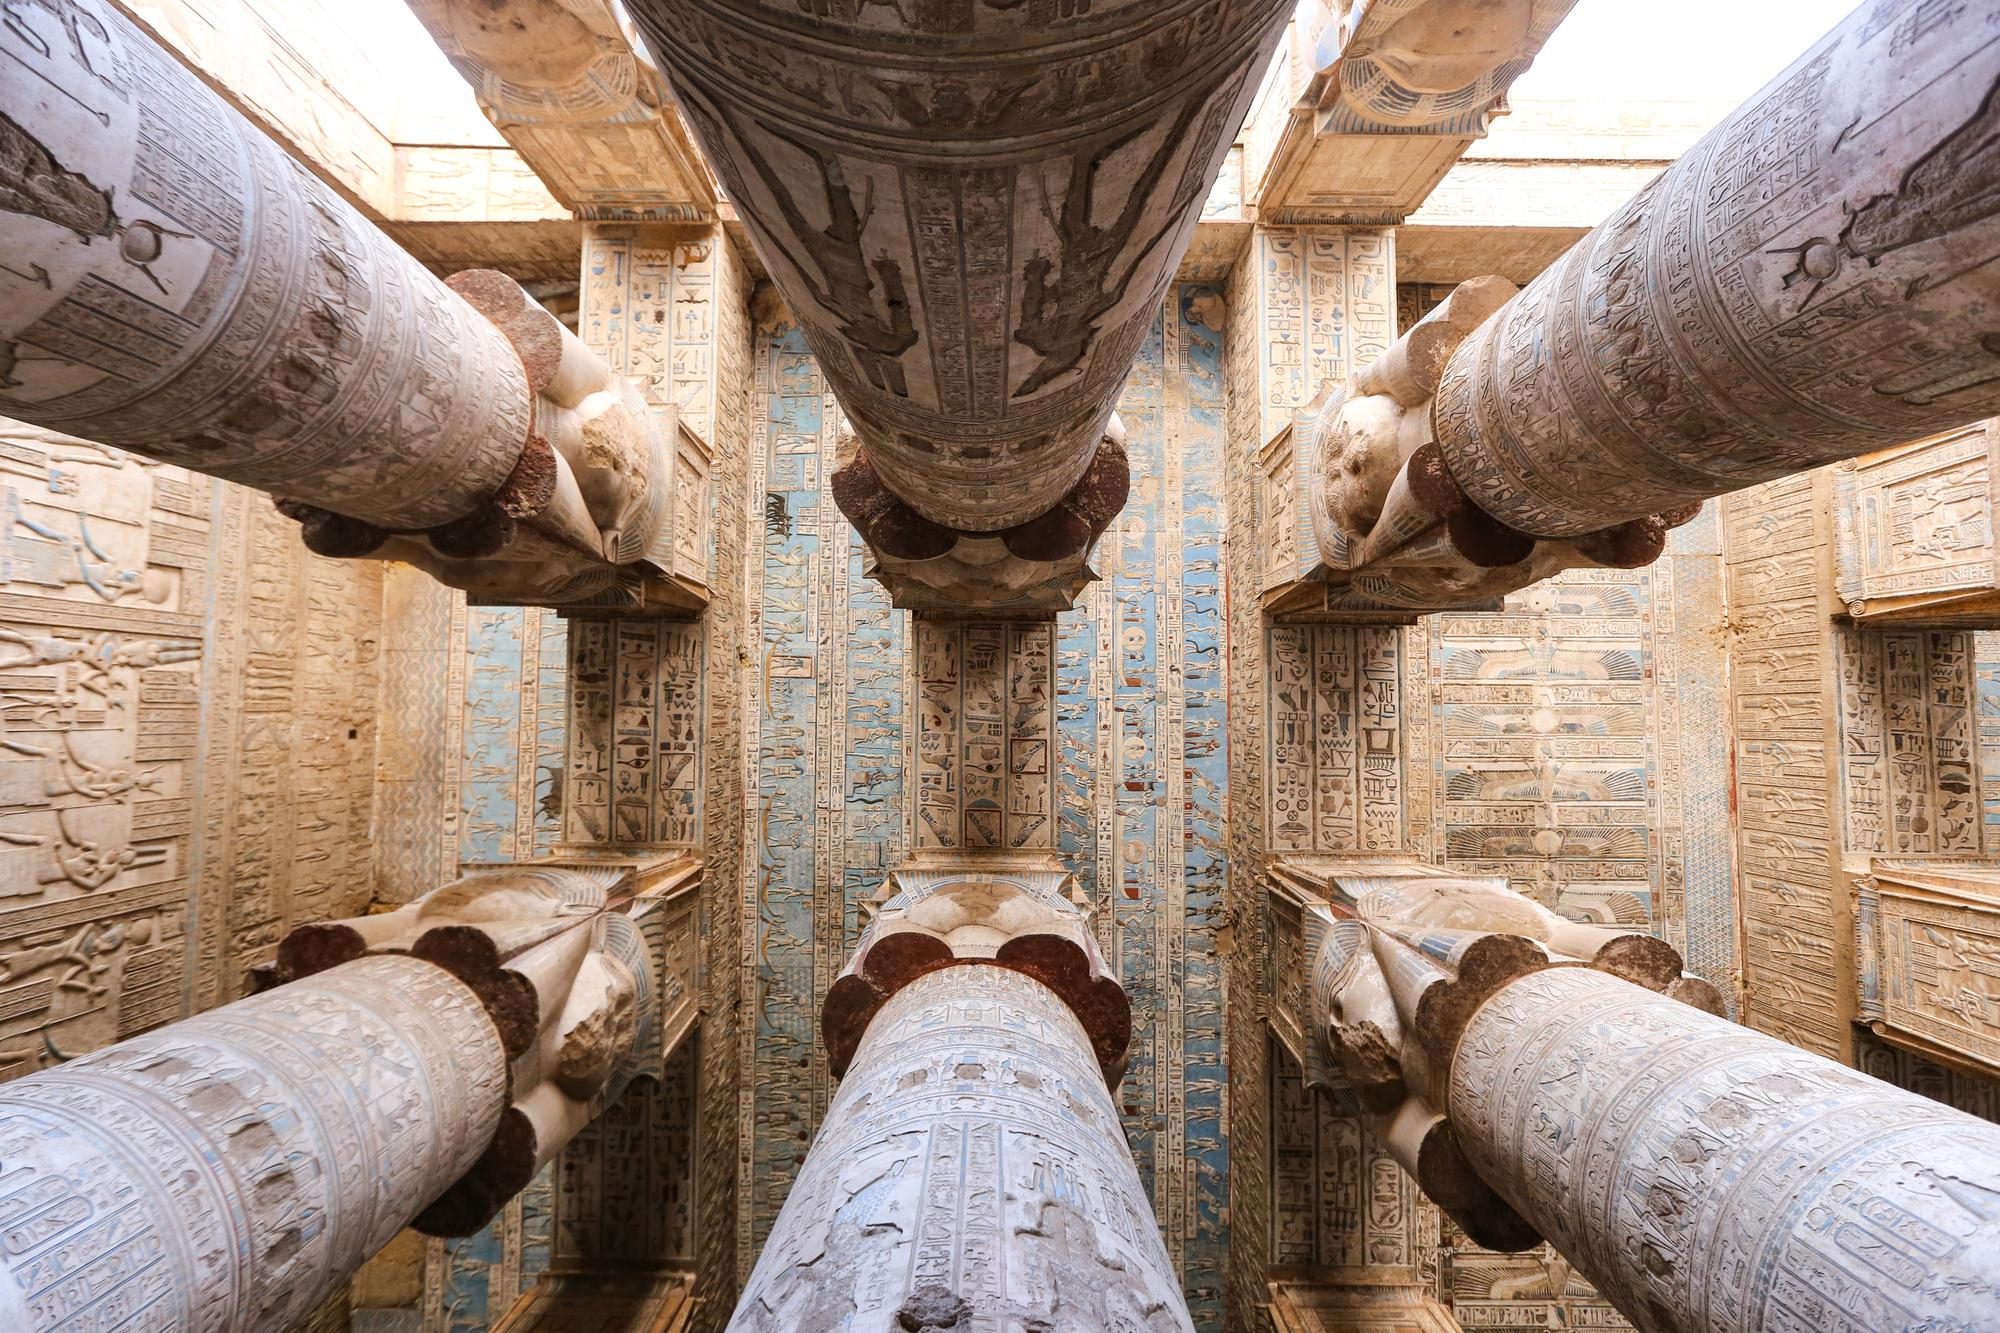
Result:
[0, 957, 508, 1333]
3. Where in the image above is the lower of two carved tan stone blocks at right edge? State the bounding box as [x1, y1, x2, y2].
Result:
[1854, 857, 2000, 1077]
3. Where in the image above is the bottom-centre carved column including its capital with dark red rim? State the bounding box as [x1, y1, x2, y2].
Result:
[730, 868, 1194, 1333]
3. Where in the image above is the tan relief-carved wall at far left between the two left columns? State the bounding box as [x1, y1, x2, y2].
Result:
[0, 422, 380, 1048]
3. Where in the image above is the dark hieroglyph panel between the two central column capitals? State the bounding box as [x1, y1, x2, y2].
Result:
[908, 620, 1056, 849]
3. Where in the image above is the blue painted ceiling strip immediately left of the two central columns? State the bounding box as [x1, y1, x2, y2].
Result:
[734, 322, 914, 1273]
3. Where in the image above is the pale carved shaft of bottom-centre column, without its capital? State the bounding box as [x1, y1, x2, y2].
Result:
[730, 963, 1194, 1333]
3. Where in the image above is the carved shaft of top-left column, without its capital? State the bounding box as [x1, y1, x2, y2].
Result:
[0, 0, 534, 528]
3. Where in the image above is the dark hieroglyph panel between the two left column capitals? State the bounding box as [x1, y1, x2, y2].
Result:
[562, 618, 706, 849]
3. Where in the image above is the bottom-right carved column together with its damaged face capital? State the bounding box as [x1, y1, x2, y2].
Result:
[1298, 867, 2000, 1333]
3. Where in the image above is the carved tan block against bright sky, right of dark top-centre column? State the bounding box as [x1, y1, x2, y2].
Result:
[1254, 0, 1576, 224]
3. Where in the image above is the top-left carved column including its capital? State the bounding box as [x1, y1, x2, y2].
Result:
[0, 0, 674, 604]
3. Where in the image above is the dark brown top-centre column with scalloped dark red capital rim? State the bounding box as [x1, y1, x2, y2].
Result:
[630, 0, 1292, 590]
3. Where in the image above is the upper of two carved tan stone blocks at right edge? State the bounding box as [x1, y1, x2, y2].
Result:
[1834, 420, 2000, 628]
